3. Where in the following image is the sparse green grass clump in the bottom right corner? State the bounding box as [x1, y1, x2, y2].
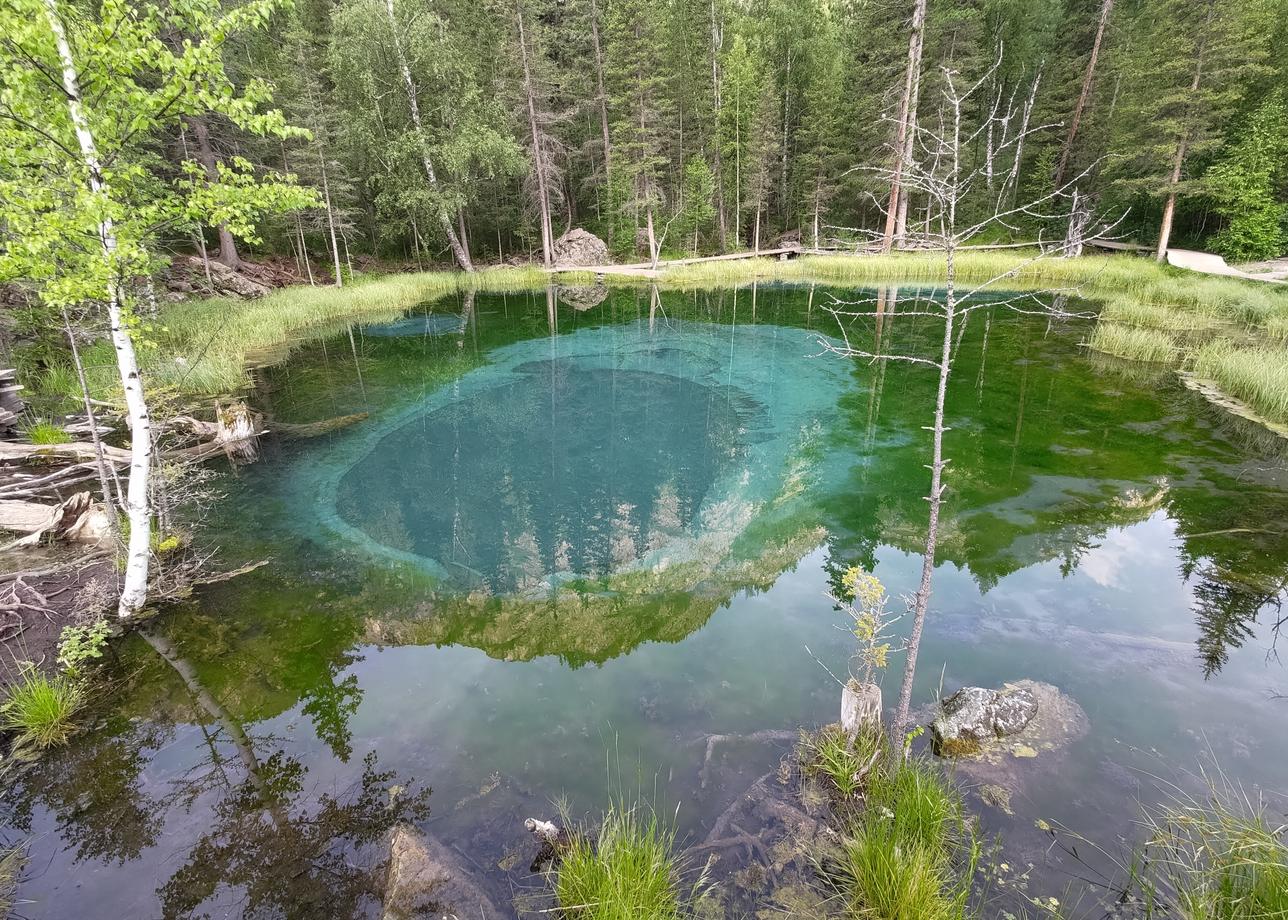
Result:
[1145, 782, 1288, 920]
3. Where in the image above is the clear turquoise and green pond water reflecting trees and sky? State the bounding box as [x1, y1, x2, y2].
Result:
[0, 286, 1288, 917]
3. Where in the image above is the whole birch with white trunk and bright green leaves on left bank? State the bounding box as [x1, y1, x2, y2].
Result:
[0, 0, 310, 618]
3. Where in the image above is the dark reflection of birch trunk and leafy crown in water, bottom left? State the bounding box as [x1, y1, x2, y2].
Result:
[143, 630, 429, 917]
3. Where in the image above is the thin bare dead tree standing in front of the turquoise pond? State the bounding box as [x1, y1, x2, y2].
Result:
[819, 55, 1112, 749]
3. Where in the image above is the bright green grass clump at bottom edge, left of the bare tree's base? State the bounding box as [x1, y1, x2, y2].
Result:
[555, 805, 684, 920]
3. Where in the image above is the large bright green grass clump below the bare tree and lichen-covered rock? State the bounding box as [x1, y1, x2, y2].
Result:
[840, 758, 980, 920]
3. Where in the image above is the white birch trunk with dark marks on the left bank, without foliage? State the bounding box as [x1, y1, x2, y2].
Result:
[45, 0, 152, 618]
